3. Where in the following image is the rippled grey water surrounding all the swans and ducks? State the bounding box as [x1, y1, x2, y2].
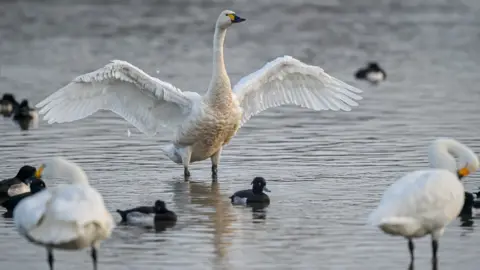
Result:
[0, 0, 480, 270]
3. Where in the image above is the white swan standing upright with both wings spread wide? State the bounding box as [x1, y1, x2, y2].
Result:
[37, 10, 362, 177]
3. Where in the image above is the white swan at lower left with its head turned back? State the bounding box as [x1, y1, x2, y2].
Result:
[13, 157, 114, 270]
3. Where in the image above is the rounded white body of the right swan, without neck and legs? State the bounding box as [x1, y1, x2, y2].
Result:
[370, 169, 465, 239]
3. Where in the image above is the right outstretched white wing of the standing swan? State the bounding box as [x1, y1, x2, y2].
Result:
[233, 56, 362, 125]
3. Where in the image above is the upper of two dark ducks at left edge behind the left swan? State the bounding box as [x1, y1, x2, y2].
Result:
[0, 165, 37, 204]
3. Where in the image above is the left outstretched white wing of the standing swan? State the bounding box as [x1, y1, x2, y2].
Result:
[37, 60, 200, 135]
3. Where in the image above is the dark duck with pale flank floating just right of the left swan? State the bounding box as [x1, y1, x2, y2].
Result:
[117, 200, 177, 230]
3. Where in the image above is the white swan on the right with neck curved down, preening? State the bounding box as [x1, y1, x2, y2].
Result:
[369, 138, 479, 263]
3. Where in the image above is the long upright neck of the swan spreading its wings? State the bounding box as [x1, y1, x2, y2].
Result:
[207, 26, 232, 104]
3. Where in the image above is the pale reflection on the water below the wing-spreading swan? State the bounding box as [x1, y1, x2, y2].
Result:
[172, 179, 235, 261]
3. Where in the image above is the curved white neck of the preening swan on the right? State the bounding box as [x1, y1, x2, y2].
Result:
[428, 138, 478, 173]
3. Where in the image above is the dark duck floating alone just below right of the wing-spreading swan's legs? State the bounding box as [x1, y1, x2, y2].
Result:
[230, 177, 270, 205]
